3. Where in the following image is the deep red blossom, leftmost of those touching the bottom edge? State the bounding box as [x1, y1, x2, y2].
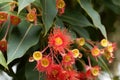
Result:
[47, 64, 62, 80]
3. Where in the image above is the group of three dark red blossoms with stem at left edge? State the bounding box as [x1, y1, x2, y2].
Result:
[0, 12, 21, 52]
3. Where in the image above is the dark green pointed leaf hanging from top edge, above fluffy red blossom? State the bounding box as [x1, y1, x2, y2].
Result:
[41, 0, 57, 34]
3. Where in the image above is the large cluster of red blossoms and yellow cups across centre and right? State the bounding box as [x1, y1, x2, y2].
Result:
[30, 28, 116, 80]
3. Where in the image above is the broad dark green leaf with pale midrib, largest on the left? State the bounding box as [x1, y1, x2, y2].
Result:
[7, 21, 41, 64]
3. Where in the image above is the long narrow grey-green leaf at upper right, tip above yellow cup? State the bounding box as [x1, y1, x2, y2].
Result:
[78, 0, 107, 38]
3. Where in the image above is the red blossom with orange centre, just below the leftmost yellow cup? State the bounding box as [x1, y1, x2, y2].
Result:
[36, 57, 52, 72]
